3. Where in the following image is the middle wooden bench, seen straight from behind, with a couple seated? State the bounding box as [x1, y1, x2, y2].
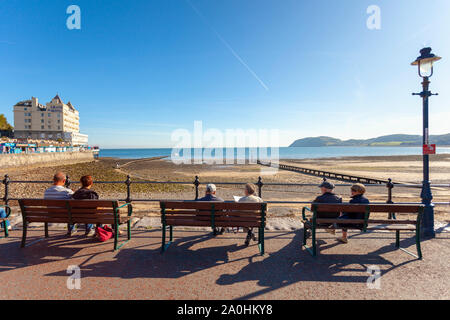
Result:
[160, 201, 267, 255]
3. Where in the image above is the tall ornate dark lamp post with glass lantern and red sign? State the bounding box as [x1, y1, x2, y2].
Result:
[412, 48, 441, 238]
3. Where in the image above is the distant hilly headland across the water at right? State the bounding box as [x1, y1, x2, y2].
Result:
[289, 133, 450, 147]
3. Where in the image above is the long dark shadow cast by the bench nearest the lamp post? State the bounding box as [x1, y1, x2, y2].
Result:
[216, 229, 417, 300]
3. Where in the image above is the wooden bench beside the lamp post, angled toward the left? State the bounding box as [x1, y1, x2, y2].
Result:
[302, 203, 424, 259]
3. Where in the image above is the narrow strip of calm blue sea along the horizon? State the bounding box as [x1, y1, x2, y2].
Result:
[99, 147, 450, 160]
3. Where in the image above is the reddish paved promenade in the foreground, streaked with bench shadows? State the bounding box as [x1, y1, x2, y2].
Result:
[0, 228, 450, 300]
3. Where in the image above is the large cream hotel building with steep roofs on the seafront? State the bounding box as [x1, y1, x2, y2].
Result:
[14, 95, 88, 146]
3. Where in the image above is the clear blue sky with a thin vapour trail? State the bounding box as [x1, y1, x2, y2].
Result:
[0, 0, 450, 148]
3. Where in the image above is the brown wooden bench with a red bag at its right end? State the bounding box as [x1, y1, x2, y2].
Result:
[19, 199, 133, 250]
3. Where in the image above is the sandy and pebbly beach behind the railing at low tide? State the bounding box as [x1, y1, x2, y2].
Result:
[0, 155, 450, 222]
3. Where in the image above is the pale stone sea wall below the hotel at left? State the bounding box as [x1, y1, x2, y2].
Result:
[0, 151, 94, 168]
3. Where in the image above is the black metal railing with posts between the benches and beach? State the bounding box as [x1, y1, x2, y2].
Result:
[2, 175, 450, 205]
